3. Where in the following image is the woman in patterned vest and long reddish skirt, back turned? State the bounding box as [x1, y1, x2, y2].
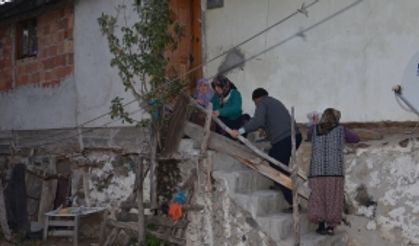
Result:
[308, 108, 359, 235]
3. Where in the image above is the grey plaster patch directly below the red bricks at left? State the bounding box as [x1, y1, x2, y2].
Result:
[0, 76, 77, 130]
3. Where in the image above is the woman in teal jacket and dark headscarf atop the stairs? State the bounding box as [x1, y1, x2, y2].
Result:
[211, 75, 250, 136]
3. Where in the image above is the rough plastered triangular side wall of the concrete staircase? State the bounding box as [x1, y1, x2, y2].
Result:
[186, 180, 275, 246]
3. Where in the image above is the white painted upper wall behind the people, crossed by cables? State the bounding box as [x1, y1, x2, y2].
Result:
[204, 0, 419, 122]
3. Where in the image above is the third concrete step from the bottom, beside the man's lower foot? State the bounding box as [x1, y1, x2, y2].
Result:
[232, 190, 288, 218]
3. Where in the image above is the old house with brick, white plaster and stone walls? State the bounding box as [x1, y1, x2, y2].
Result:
[0, 0, 419, 245]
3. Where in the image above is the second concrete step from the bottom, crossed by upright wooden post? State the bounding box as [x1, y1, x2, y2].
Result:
[256, 213, 317, 241]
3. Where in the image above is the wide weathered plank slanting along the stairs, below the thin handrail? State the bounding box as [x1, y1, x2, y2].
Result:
[185, 122, 309, 199]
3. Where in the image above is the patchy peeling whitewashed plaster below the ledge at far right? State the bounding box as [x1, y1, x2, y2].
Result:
[346, 136, 419, 245]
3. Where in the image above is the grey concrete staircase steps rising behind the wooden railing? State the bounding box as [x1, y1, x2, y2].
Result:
[213, 153, 348, 246]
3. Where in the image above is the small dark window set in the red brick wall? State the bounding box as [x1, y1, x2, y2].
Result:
[16, 19, 38, 59]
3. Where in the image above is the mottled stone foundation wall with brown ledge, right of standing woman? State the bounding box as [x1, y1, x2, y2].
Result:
[297, 128, 419, 246]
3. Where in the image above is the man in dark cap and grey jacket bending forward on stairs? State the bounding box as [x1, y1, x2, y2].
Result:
[231, 88, 302, 207]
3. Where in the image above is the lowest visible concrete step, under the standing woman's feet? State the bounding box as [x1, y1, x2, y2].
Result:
[277, 230, 348, 246]
